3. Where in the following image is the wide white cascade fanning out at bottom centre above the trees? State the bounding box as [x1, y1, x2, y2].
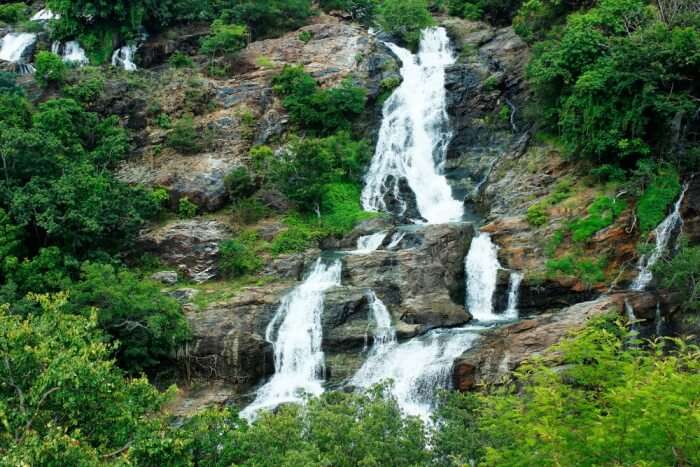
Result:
[350, 328, 478, 422]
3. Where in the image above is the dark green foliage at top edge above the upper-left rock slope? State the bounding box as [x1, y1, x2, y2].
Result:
[223, 0, 313, 39]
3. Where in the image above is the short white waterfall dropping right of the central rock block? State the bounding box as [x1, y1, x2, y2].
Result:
[465, 233, 504, 321]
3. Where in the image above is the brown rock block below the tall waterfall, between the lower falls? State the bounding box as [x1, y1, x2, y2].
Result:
[343, 224, 473, 335]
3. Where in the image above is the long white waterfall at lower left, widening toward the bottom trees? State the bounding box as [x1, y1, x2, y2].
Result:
[241, 258, 341, 419]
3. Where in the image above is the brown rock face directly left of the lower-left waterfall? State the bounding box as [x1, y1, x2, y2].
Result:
[178, 284, 289, 393]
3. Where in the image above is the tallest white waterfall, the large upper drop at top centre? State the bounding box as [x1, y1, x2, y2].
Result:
[362, 28, 464, 223]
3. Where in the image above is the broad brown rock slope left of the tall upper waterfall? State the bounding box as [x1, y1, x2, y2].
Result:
[118, 15, 398, 211]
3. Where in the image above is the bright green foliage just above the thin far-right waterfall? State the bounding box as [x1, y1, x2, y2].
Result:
[636, 167, 681, 232]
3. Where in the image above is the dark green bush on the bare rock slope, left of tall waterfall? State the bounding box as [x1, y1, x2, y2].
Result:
[272, 66, 367, 135]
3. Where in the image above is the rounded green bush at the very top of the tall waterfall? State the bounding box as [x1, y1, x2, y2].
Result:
[377, 0, 435, 50]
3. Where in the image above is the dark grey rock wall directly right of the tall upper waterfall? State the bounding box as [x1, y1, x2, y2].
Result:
[443, 18, 529, 199]
